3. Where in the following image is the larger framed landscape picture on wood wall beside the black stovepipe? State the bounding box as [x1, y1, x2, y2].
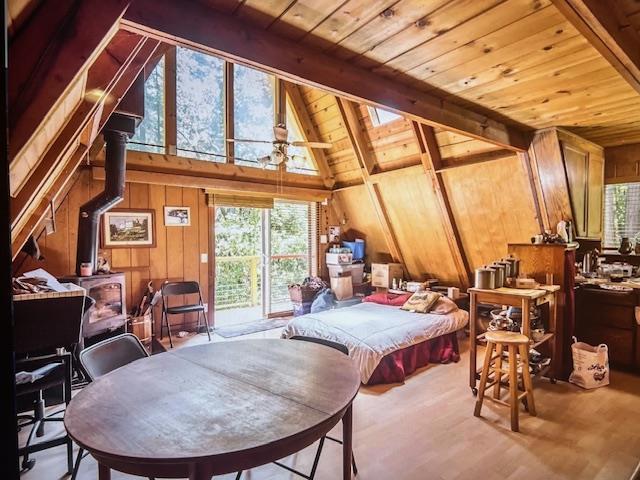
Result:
[102, 208, 156, 248]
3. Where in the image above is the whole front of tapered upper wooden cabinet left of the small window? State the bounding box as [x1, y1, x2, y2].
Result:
[558, 131, 604, 239]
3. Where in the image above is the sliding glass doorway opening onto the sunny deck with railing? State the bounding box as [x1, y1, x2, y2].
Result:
[214, 201, 317, 327]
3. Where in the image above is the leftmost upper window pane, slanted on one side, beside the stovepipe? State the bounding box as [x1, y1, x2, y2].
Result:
[129, 57, 165, 153]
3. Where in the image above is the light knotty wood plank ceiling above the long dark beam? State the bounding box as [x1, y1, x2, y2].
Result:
[202, 0, 640, 146]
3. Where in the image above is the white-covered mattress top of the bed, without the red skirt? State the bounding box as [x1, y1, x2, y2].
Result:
[282, 302, 469, 383]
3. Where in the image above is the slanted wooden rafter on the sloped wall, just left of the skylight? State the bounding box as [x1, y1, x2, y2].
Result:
[336, 97, 408, 273]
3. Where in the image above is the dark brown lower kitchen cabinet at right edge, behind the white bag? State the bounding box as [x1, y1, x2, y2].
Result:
[576, 287, 640, 369]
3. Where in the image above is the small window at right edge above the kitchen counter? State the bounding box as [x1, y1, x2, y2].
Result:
[604, 183, 640, 248]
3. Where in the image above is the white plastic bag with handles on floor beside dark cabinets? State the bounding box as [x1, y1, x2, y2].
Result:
[569, 337, 609, 388]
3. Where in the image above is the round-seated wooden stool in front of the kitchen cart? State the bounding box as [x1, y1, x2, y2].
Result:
[473, 331, 536, 432]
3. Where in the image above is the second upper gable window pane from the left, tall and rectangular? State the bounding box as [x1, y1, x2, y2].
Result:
[176, 47, 226, 162]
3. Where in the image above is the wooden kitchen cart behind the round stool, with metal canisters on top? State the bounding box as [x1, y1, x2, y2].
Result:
[468, 285, 560, 395]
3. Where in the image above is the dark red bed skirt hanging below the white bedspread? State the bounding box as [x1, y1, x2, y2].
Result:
[367, 332, 460, 385]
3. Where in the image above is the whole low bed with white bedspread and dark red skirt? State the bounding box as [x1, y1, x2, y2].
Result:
[282, 302, 469, 385]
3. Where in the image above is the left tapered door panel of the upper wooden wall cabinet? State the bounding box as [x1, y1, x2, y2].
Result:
[562, 142, 588, 237]
